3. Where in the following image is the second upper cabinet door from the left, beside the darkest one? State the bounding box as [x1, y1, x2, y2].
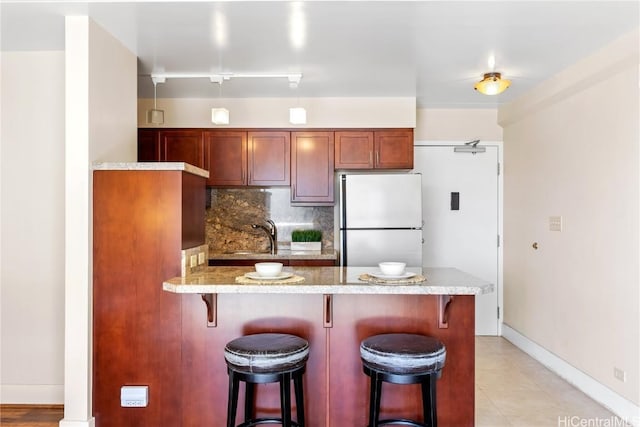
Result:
[159, 129, 209, 170]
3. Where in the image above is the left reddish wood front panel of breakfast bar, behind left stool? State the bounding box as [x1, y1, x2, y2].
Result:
[181, 294, 327, 427]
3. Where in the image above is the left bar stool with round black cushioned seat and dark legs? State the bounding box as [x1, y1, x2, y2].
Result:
[224, 333, 309, 427]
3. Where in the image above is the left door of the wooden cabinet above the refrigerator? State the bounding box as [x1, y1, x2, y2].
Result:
[335, 131, 374, 169]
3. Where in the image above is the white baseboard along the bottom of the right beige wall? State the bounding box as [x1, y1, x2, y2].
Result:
[502, 323, 640, 427]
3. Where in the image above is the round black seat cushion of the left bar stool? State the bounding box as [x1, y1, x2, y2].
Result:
[224, 333, 309, 373]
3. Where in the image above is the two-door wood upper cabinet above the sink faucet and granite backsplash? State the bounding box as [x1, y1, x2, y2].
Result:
[204, 130, 291, 187]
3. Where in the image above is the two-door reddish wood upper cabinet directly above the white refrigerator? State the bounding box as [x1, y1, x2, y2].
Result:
[335, 129, 413, 169]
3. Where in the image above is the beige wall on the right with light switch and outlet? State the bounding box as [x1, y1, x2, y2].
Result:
[499, 31, 640, 407]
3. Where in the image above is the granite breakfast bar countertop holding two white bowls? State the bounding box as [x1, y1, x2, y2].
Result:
[162, 267, 494, 295]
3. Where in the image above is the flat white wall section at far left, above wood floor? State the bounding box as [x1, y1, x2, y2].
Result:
[0, 52, 64, 404]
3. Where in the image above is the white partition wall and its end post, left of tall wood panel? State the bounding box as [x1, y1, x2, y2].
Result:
[60, 16, 137, 427]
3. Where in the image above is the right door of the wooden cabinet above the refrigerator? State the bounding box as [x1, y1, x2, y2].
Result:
[374, 129, 413, 169]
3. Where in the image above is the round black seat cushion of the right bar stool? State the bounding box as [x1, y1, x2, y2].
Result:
[360, 333, 447, 374]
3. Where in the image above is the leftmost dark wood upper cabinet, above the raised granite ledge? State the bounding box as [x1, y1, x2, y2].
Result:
[138, 129, 209, 171]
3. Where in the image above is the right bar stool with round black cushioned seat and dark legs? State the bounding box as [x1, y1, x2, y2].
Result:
[360, 333, 447, 427]
